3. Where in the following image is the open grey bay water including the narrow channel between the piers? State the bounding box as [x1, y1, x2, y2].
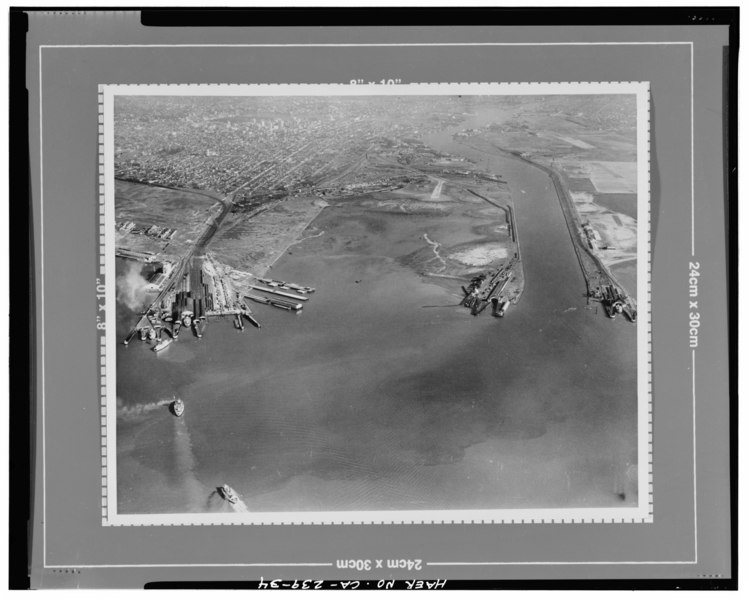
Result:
[117, 120, 637, 513]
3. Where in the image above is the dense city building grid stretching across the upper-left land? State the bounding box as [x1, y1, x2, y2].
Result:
[115, 96, 474, 195]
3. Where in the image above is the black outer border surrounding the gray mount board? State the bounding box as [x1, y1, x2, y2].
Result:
[8, 6, 739, 590]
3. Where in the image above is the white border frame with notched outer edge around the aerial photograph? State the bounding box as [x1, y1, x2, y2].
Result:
[99, 82, 653, 525]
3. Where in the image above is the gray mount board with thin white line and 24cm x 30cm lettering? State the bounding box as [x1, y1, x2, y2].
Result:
[27, 12, 730, 587]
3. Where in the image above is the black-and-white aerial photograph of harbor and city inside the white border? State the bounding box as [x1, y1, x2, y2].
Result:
[114, 94, 646, 515]
